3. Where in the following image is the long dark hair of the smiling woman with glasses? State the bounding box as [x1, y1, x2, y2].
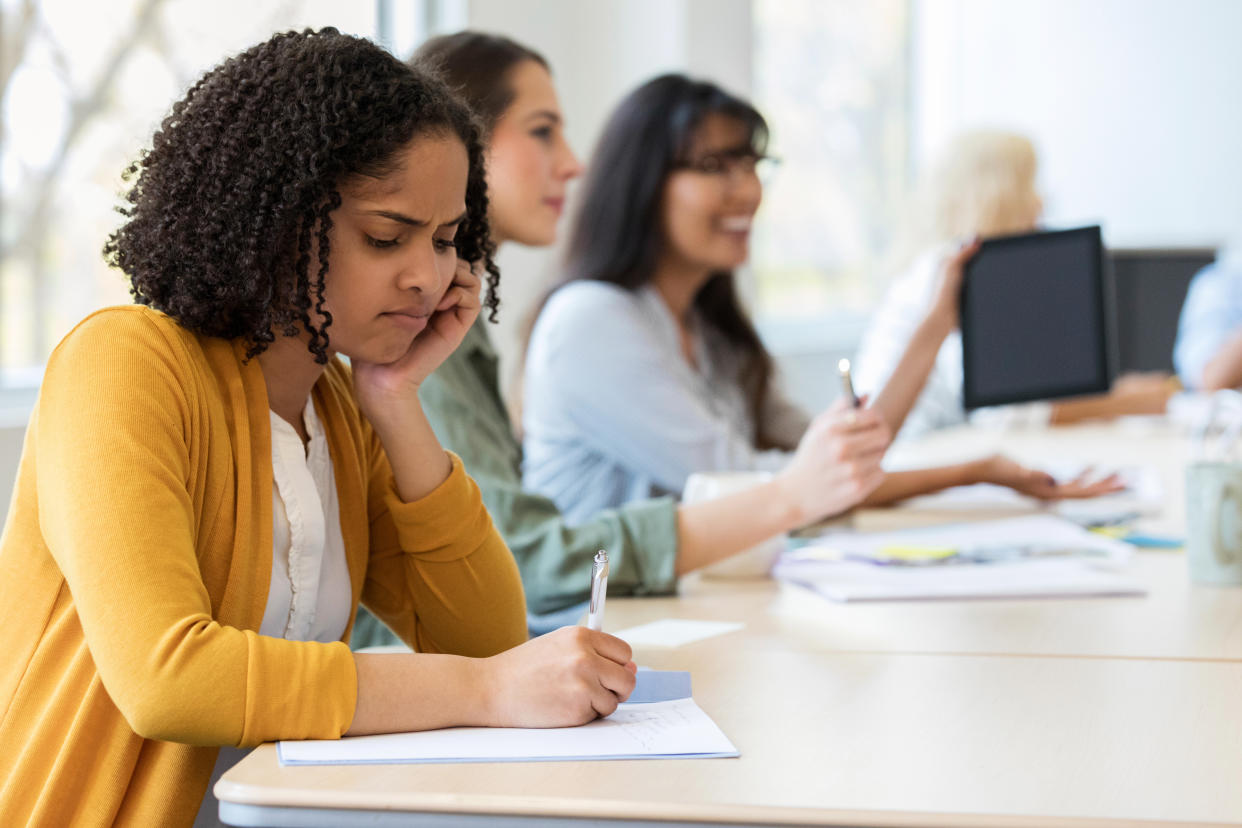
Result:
[558, 74, 792, 448]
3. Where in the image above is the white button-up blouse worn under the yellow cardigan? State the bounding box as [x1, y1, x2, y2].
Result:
[194, 398, 353, 828]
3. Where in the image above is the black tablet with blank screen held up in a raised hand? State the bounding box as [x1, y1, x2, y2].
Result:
[961, 227, 1110, 410]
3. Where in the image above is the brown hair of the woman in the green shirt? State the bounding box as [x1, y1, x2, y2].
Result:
[410, 30, 550, 143]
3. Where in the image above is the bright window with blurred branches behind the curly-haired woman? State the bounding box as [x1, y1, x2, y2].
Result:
[0, 0, 449, 387]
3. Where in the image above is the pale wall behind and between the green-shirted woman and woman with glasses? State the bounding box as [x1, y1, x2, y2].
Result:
[468, 0, 750, 397]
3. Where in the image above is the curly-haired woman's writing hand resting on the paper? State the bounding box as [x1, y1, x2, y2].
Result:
[483, 627, 637, 727]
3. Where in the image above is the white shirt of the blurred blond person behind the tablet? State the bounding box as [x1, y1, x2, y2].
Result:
[853, 246, 1052, 439]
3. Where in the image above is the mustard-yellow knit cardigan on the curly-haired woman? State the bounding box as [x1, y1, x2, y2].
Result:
[0, 307, 525, 826]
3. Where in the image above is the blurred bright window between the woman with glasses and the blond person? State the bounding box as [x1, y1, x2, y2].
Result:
[751, 0, 910, 337]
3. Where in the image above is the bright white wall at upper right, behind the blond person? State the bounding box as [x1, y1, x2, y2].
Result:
[913, 0, 1242, 247]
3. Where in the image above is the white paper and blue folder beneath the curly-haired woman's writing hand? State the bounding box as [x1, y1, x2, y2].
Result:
[277, 670, 738, 765]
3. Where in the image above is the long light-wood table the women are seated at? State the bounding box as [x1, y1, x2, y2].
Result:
[216, 428, 1242, 827]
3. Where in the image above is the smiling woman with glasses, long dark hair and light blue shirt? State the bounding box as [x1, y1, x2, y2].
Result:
[523, 74, 1112, 523]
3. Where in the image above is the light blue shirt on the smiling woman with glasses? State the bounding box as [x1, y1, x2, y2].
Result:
[522, 282, 807, 523]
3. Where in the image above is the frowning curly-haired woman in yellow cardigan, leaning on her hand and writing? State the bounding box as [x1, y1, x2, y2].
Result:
[0, 29, 633, 826]
